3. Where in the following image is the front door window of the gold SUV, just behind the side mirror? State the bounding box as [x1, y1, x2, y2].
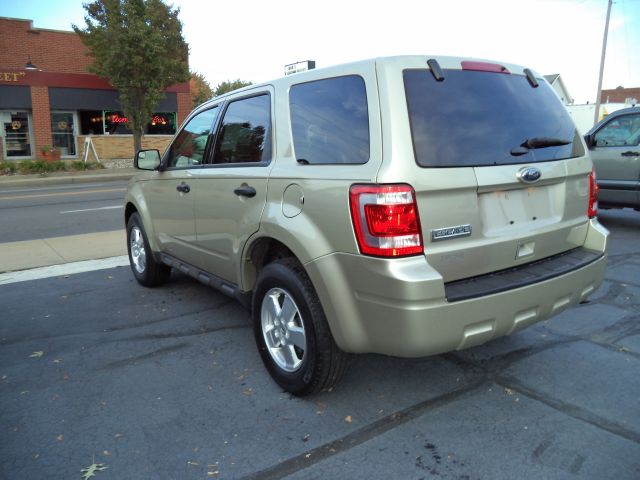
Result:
[166, 106, 218, 168]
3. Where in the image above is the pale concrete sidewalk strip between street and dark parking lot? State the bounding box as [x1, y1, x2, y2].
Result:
[0, 228, 127, 273]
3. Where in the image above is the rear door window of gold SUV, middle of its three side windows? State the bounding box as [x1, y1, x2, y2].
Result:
[213, 95, 271, 164]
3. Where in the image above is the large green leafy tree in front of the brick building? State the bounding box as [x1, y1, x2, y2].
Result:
[72, 0, 189, 151]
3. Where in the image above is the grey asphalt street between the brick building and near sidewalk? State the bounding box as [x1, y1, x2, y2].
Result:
[0, 181, 127, 243]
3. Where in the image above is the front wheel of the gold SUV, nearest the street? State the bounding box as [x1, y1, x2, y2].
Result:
[127, 212, 171, 287]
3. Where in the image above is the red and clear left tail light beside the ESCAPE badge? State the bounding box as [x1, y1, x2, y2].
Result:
[349, 185, 424, 257]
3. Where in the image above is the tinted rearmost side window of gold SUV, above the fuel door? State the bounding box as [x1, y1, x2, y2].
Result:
[289, 75, 369, 164]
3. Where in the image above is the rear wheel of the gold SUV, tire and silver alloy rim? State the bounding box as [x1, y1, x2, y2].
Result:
[252, 258, 349, 396]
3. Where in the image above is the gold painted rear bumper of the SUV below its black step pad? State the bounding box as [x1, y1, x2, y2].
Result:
[306, 220, 608, 357]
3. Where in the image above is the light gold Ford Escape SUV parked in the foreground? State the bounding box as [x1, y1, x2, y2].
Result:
[125, 56, 608, 395]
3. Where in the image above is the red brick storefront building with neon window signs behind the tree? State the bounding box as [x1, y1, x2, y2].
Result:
[0, 17, 191, 161]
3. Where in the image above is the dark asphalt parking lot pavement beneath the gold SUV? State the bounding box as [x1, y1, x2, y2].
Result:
[0, 211, 640, 480]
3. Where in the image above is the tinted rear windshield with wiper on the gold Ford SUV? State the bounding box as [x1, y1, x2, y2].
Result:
[404, 69, 584, 167]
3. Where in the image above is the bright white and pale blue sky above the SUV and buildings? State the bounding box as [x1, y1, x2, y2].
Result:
[0, 0, 640, 104]
